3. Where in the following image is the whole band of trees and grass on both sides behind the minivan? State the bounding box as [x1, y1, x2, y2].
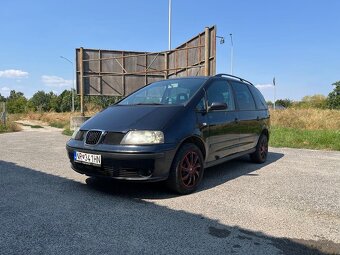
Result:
[0, 81, 340, 150]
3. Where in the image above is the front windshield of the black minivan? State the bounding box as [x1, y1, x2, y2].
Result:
[118, 78, 205, 105]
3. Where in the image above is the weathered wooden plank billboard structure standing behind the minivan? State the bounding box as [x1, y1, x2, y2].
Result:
[76, 26, 216, 113]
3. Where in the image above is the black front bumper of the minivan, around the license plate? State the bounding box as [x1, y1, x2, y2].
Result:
[66, 140, 176, 181]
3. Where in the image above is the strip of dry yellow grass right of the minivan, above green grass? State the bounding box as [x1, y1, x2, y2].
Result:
[270, 108, 340, 130]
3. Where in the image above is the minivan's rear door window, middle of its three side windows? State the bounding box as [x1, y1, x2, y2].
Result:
[231, 81, 256, 111]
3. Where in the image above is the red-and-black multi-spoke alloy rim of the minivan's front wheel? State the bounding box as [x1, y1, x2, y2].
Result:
[179, 151, 202, 188]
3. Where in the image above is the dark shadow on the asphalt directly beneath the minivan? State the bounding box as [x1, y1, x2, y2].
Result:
[86, 152, 284, 199]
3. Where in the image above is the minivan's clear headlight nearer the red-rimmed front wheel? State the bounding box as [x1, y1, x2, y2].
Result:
[120, 130, 164, 145]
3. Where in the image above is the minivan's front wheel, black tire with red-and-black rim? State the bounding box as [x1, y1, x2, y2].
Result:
[167, 143, 204, 195]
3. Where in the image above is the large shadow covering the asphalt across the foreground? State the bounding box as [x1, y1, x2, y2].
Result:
[0, 160, 334, 255]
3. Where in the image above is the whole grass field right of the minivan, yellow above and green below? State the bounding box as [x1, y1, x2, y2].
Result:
[270, 108, 340, 150]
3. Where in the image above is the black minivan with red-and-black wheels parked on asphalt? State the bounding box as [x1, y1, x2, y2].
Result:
[66, 74, 270, 194]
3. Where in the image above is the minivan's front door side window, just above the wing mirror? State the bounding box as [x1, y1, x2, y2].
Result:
[207, 80, 235, 111]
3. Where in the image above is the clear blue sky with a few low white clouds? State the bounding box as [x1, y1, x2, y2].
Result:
[0, 0, 340, 100]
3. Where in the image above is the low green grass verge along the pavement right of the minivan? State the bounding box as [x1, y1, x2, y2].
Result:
[269, 126, 340, 151]
